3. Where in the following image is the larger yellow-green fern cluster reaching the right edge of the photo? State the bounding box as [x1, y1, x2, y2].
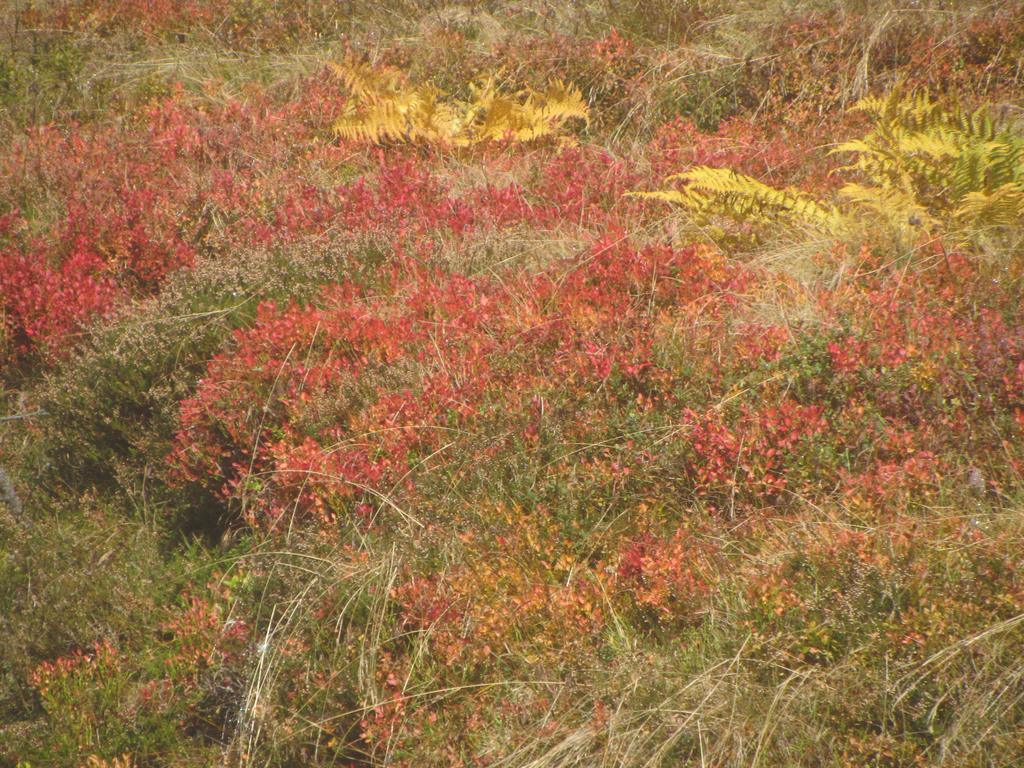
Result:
[635, 90, 1024, 243]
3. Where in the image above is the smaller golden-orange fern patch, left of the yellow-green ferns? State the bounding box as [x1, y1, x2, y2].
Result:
[332, 60, 590, 146]
